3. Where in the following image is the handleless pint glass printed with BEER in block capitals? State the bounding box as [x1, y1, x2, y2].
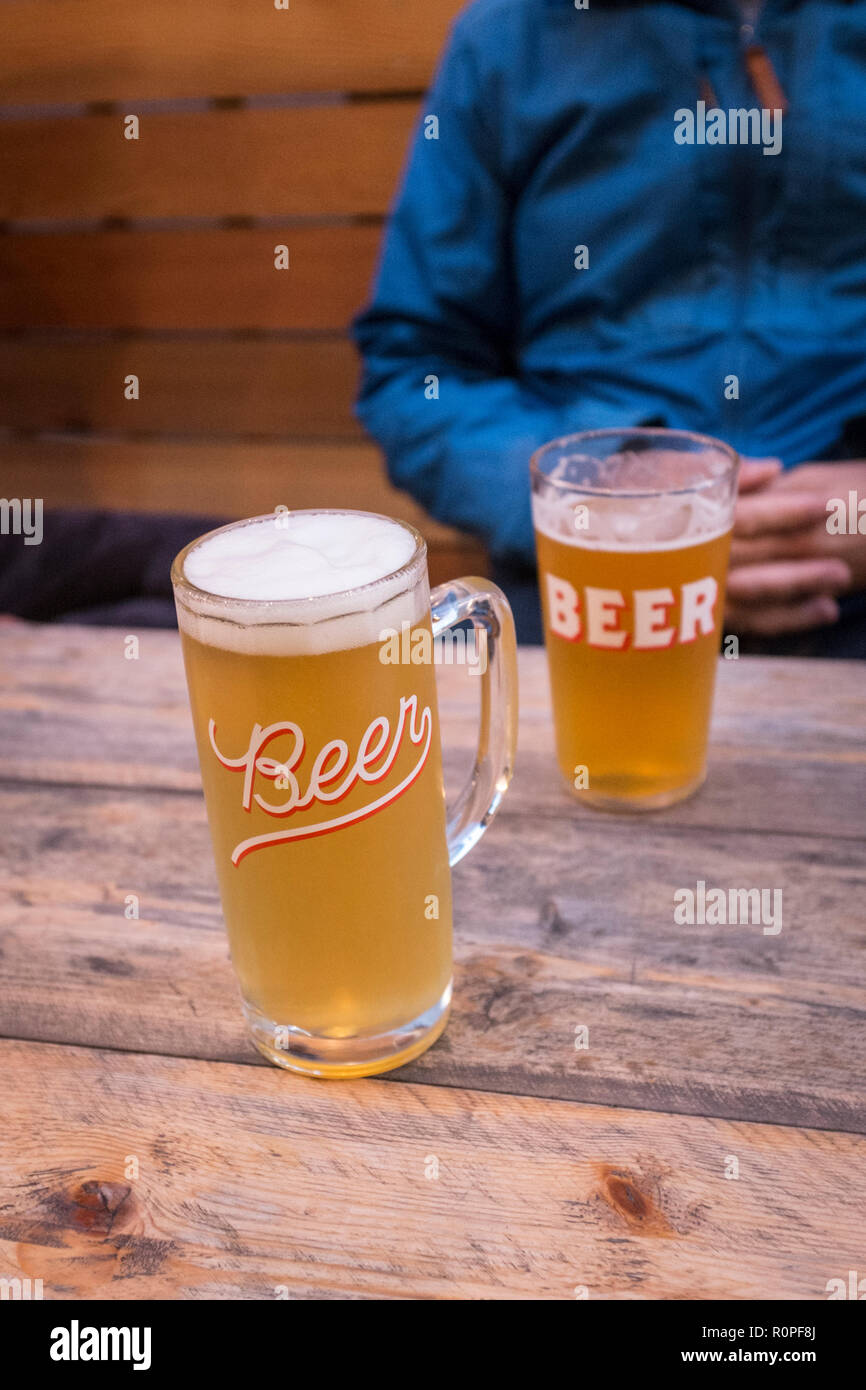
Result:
[531, 428, 740, 810]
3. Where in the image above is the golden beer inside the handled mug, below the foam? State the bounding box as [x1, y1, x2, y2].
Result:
[182, 622, 452, 1037]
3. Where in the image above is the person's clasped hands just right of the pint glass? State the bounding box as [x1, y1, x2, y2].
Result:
[726, 459, 866, 637]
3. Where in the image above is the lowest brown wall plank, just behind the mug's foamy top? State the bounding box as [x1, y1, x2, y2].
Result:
[0, 436, 487, 582]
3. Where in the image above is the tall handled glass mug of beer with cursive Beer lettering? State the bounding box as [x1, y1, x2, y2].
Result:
[172, 512, 517, 1077]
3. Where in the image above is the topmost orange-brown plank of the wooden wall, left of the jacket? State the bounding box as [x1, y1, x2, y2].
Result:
[0, 0, 463, 104]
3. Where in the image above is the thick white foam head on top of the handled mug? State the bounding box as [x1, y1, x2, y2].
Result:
[178, 512, 430, 656]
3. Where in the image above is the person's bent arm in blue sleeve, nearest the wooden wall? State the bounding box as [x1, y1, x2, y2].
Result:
[348, 14, 563, 562]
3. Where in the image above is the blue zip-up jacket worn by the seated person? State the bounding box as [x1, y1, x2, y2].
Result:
[354, 0, 866, 560]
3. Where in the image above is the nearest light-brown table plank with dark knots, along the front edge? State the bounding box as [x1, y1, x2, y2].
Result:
[0, 1038, 866, 1300]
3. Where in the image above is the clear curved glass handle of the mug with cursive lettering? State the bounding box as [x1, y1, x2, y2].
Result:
[430, 580, 517, 865]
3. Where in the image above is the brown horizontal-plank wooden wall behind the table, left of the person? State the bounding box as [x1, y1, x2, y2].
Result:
[0, 0, 485, 578]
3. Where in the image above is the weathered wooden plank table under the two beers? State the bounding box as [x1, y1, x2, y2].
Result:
[0, 624, 866, 1298]
